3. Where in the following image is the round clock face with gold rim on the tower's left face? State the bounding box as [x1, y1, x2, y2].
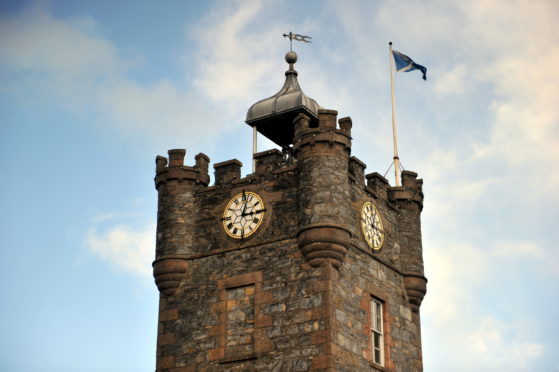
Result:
[221, 191, 266, 239]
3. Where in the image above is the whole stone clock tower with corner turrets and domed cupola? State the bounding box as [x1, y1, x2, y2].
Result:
[153, 52, 427, 372]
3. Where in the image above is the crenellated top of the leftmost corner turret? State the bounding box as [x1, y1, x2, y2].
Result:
[155, 149, 210, 190]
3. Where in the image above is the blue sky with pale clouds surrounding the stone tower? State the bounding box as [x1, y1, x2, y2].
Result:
[0, 0, 559, 372]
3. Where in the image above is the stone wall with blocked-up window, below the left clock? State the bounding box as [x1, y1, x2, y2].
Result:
[158, 239, 336, 371]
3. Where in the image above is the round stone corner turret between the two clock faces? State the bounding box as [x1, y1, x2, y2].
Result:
[294, 109, 352, 268]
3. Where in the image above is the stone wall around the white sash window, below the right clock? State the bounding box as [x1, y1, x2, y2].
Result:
[334, 249, 421, 372]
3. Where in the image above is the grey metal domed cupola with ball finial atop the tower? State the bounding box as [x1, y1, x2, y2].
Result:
[246, 51, 322, 146]
